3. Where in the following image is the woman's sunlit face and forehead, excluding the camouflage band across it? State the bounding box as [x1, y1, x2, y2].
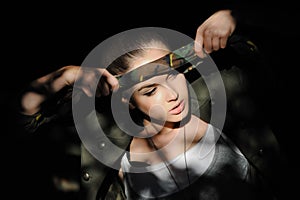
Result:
[127, 49, 189, 122]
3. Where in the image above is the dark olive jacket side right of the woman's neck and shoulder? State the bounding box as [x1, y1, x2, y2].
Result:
[191, 46, 287, 198]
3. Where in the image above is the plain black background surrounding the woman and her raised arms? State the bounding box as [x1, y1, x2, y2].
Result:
[0, 1, 300, 199]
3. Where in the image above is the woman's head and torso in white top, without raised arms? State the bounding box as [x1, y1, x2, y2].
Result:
[103, 35, 272, 199]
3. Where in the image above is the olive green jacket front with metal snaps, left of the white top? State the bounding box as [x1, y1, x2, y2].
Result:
[78, 111, 131, 200]
